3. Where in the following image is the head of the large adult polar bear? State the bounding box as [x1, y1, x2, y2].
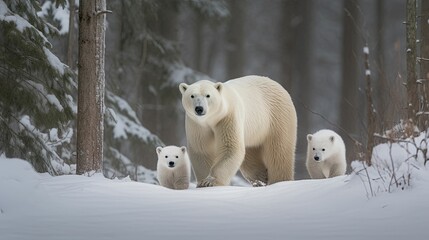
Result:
[179, 80, 223, 122]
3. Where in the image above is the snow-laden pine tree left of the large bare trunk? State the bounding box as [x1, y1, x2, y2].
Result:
[0, 0, 76, 174]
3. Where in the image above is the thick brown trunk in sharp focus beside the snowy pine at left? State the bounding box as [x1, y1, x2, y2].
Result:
[76, 0, 106, 174]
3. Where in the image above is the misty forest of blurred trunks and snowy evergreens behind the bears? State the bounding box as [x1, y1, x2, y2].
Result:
[0, 0, 429, 181]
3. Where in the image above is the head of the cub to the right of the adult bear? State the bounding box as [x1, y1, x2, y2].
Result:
[307, 132, 337, 162]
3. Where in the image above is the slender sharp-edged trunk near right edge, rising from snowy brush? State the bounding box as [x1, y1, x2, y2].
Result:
[406, 0, 419, 124]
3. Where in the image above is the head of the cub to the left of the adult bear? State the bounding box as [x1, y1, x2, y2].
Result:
[156, 146, 186, 168]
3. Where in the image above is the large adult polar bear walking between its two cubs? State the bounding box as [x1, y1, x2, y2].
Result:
[179, 76, 297, 187]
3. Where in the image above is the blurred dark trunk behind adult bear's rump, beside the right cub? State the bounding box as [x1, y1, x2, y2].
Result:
[282, 0, 314, 179]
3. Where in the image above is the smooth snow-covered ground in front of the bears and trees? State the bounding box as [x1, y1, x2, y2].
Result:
[0, 152, 429, 240]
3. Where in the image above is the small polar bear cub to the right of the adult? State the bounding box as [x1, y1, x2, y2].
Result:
[306, 129, 347, 179]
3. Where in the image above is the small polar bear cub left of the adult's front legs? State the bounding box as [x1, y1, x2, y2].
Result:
[156, 146, 191, 190]
